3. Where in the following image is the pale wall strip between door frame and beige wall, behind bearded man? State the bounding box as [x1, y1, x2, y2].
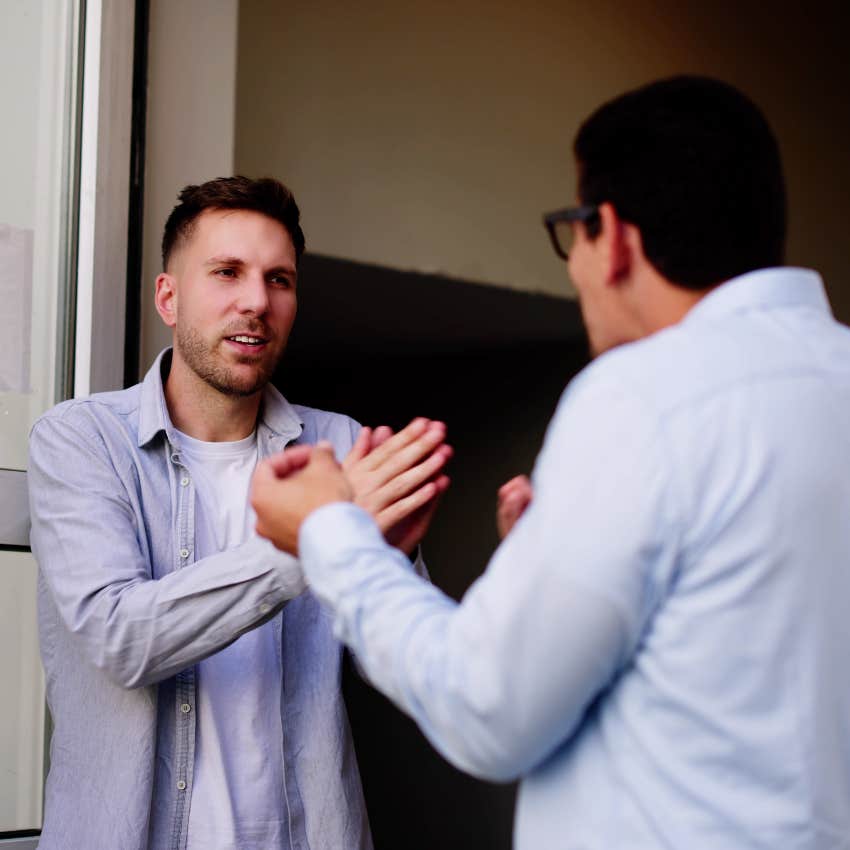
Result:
[141, 0, 238, 373]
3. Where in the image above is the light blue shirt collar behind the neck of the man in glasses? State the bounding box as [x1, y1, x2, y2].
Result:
[682, 266, 832, 323]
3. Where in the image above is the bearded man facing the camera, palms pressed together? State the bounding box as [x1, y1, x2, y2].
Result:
[29, 177, 450, 850]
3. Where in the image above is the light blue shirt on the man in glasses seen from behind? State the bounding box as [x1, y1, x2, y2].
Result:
[300, 268, 850, 850]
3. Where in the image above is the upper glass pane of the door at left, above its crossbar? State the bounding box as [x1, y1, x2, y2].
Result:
[0, 0, 80, 469]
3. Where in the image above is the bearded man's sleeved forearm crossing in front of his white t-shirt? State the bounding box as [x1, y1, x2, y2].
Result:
[33, 531, 304, 688]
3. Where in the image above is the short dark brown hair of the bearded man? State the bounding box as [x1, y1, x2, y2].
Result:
[162, 177, 305, 269]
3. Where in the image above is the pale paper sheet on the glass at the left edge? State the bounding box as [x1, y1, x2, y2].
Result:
[0, 224, 33, 393]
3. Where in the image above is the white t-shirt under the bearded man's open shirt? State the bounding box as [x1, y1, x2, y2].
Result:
[180, 433, 289, 850]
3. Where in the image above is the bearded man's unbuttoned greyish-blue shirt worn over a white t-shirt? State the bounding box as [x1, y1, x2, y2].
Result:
[29, 346, 371, 850]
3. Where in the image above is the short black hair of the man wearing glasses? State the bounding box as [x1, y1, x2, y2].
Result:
[574, 76, 786, 289]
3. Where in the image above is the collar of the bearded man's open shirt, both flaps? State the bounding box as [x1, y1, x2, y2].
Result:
[138, 348, 304, 448]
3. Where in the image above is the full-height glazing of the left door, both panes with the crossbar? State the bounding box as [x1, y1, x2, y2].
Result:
[0, 0, 83, 839]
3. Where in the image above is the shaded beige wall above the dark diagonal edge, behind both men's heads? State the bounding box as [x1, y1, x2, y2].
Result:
[235, 0, 850, 319]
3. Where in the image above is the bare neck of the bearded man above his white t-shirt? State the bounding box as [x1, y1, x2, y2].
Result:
[165, 353, 263, 443]
